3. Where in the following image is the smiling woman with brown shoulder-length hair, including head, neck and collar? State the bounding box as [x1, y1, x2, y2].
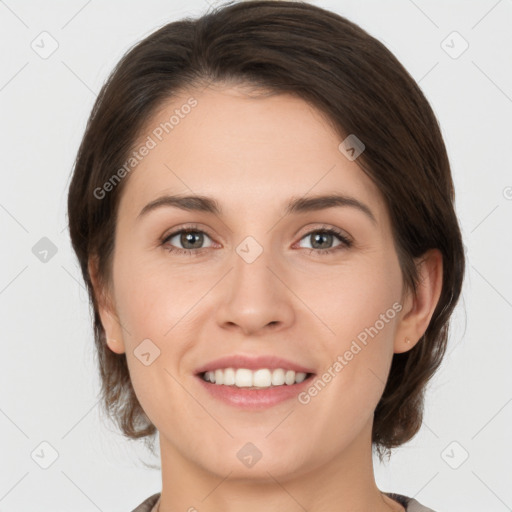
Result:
[68, 1, 464, 512]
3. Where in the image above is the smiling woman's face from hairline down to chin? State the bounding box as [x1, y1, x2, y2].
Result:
[98, 87, 414, 478]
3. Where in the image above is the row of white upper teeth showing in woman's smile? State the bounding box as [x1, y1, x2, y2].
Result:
[204, 368, 306, 388]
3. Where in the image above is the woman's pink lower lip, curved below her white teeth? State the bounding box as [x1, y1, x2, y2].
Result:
[196, 374, 314, 409]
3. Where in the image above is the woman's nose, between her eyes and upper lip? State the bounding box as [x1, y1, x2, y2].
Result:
[216, 240, 294, 336]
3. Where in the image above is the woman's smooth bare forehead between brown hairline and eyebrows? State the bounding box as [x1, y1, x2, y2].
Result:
[120, 86, 384, 224]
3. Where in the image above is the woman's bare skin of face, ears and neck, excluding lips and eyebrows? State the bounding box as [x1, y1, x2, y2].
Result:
[89, 85, 442, 512]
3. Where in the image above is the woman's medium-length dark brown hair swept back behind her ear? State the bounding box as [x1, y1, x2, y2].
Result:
[68, 0, 465, 455]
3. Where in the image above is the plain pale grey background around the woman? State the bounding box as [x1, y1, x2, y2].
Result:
[0, 0, 512, 512]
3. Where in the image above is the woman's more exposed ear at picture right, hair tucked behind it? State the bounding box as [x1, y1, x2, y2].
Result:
[393, 249, 443, 354]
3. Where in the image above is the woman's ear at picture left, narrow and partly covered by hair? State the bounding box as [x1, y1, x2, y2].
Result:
[87, 256, 125, 354]
